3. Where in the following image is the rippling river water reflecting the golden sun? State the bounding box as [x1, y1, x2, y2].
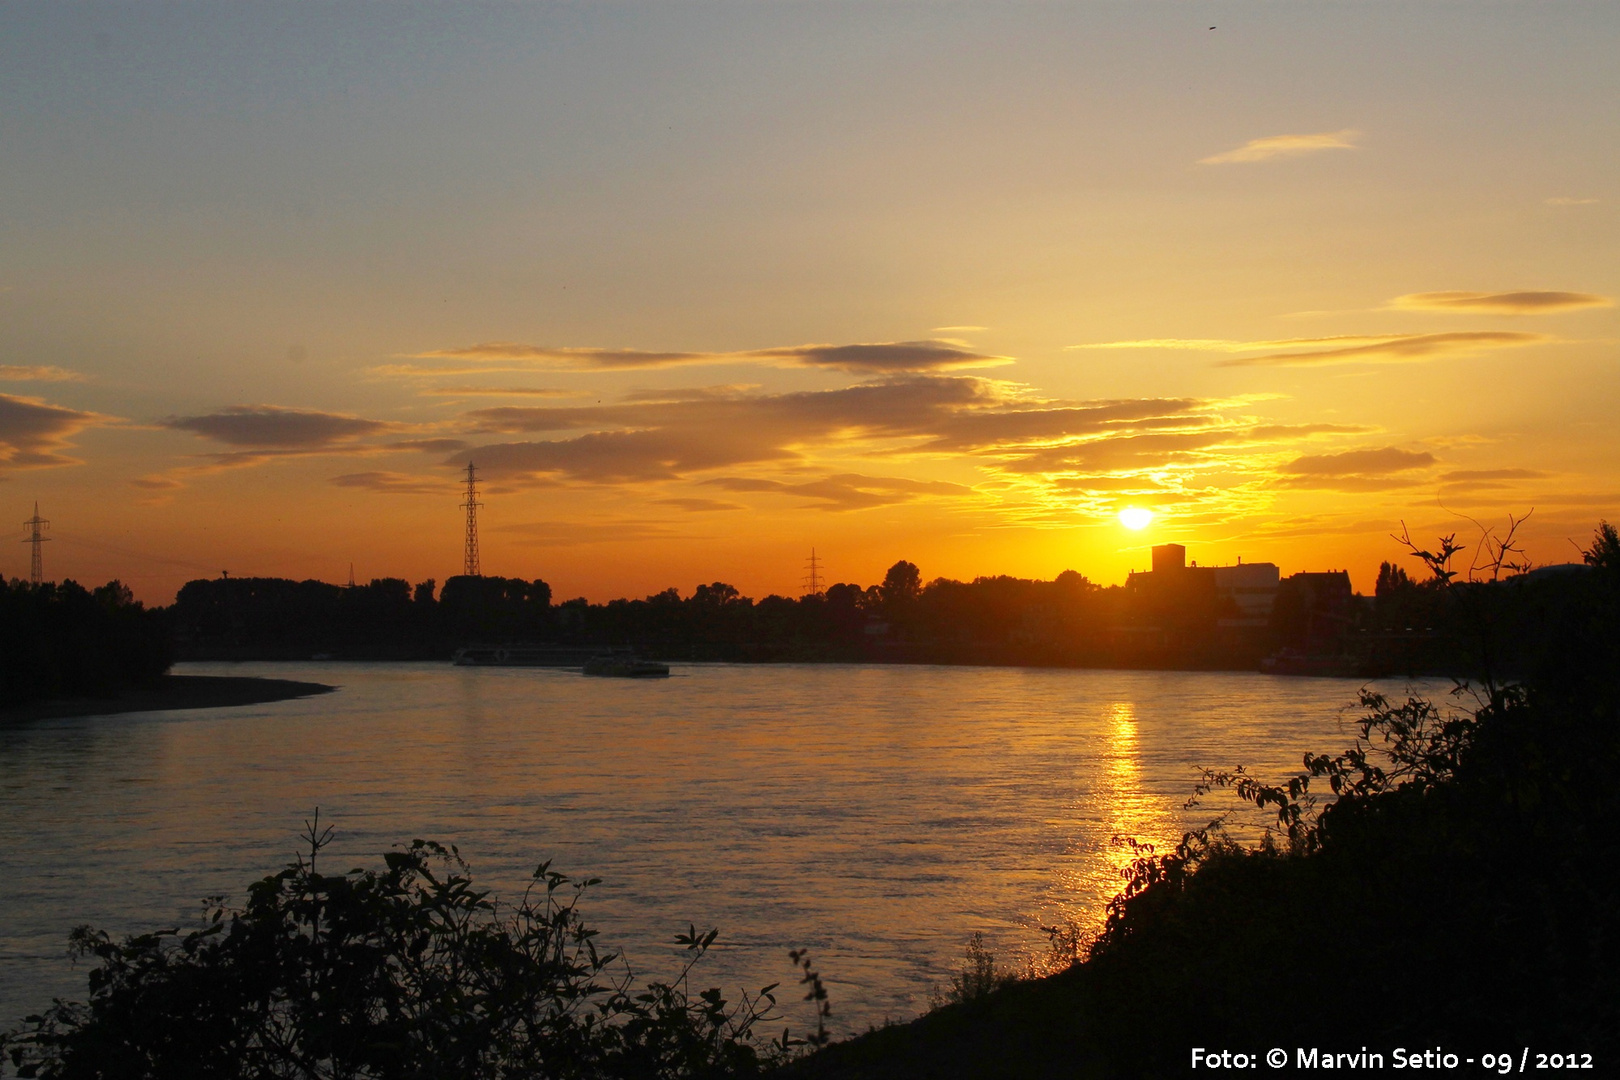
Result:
[0, 662, 1440, 1033]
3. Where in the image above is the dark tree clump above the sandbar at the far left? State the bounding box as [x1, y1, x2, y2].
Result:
[0, 578, 173, 708]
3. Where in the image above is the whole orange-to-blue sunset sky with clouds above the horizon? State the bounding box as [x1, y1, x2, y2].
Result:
[0, 0, 1620, 602]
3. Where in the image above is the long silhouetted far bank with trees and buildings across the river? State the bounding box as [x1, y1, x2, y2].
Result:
[165, 550, 1607, 675]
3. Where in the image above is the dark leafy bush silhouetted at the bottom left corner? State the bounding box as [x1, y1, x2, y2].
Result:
[0, 826, 792, 1080]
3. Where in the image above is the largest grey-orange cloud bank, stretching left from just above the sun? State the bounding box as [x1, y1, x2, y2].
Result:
[447, 376, 1369, 528]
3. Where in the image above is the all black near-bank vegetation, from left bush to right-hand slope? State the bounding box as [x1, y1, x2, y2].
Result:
[5, 525, 1620, 1080]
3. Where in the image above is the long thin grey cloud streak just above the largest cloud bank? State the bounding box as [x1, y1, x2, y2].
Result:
[405, 338, 1013, 376]
